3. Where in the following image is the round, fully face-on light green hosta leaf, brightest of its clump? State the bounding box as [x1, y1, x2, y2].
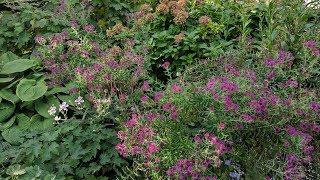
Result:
[16, 79, 48, 101]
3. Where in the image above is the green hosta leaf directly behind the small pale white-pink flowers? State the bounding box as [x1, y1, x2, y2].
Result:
[35, 96, 59, 118]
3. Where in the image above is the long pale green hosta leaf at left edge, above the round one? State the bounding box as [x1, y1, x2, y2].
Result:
[0, 59, 37, 74]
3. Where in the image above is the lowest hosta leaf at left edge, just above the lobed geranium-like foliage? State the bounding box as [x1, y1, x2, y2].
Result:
[1, 127, 24, 144]
